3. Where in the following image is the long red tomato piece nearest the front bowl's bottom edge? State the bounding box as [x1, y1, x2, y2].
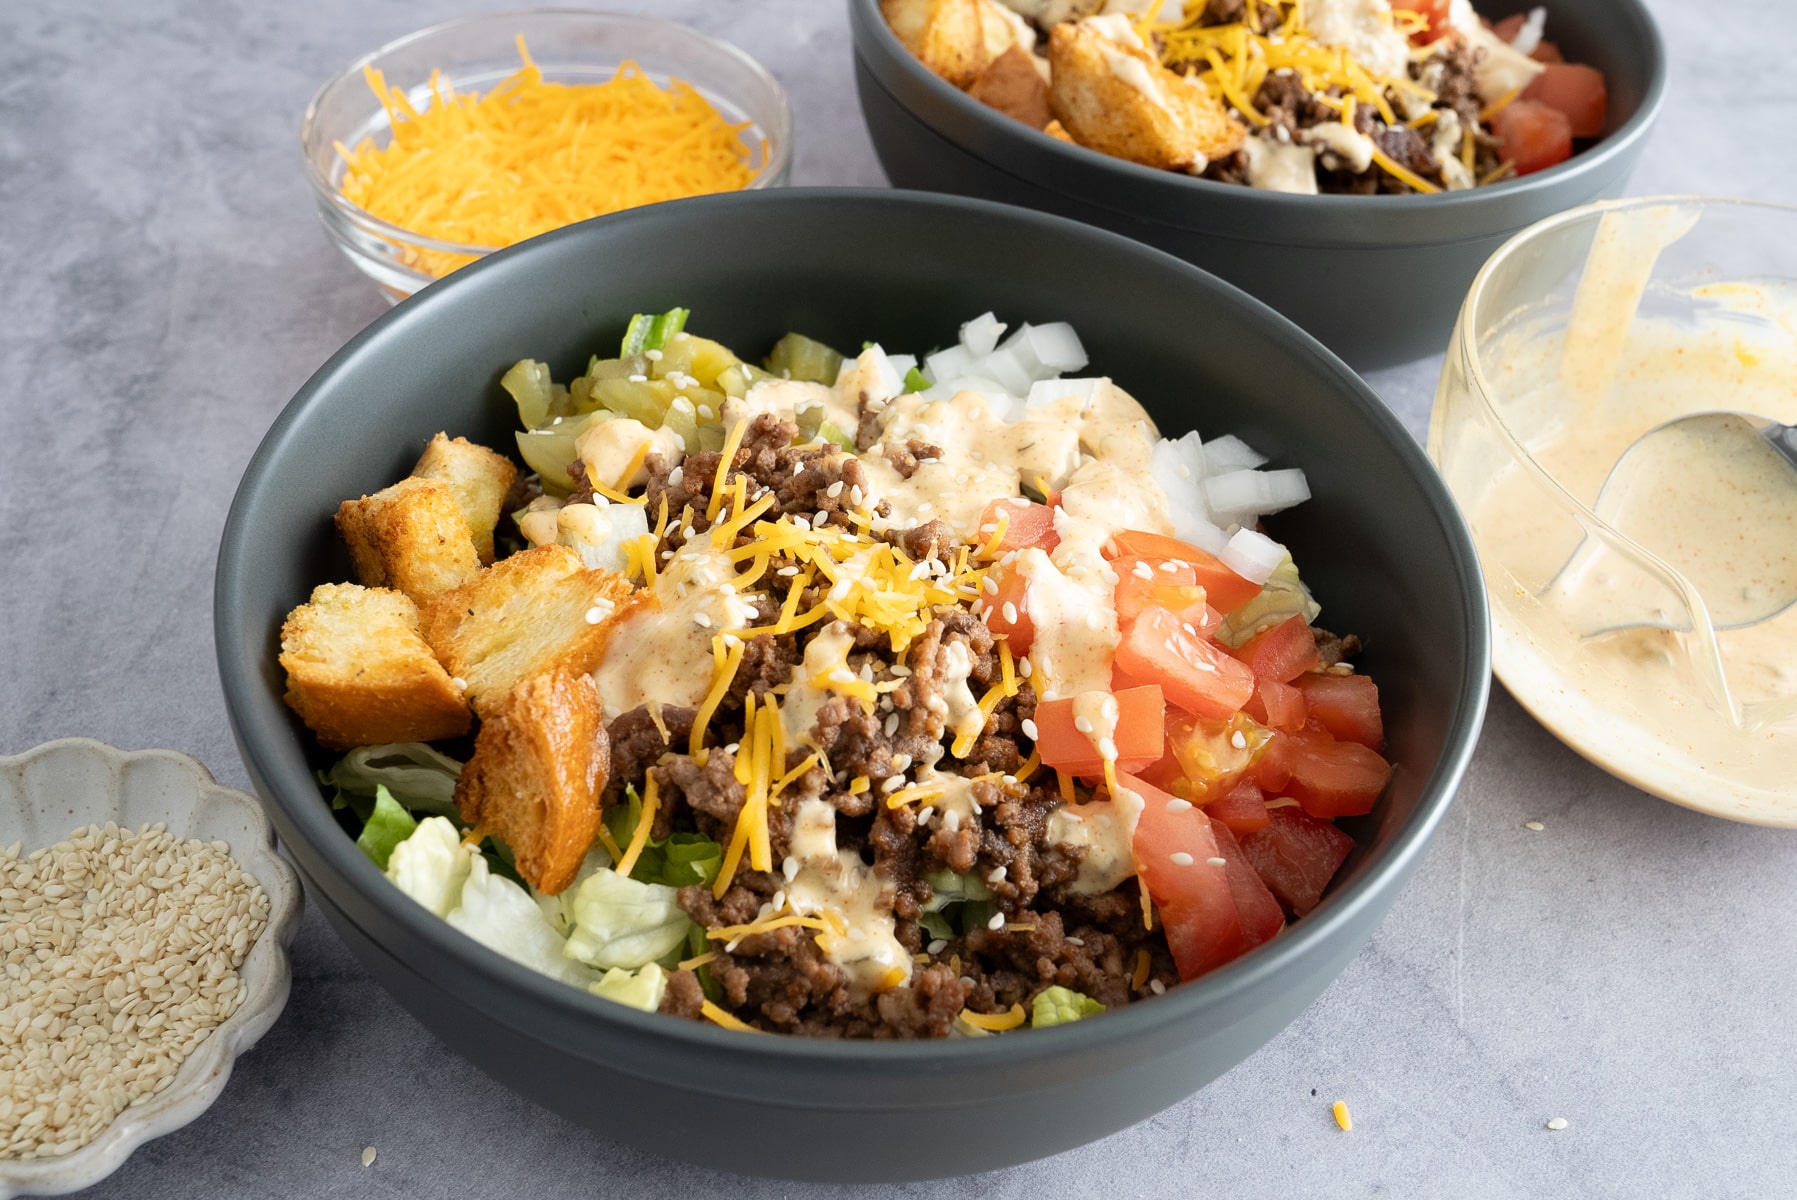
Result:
[1121, 776, 1251, 979]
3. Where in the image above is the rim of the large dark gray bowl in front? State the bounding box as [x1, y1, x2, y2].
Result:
[214, 189, 1492, 1077]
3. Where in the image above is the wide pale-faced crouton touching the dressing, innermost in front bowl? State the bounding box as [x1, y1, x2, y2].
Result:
[419, 544, 654, 717]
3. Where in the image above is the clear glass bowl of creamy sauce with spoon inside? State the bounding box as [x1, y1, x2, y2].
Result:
[1429, 198, 1797, 826]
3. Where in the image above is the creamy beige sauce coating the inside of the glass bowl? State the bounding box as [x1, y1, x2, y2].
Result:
[1441, 207, 1797, 825]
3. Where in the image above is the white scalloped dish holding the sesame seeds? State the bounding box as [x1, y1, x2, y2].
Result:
[0, 738, 300, 1200]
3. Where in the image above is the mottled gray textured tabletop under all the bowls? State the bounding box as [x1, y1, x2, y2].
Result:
[0, 0, 1797, 1200]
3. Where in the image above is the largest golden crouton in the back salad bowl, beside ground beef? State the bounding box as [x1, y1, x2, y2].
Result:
[1048, 22, 1244, 171]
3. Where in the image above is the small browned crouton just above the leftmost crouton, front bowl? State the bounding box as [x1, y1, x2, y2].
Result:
[338, 478, 480, 607]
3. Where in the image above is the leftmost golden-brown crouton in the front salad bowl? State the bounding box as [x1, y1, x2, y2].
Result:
[280, 584, 469, 749]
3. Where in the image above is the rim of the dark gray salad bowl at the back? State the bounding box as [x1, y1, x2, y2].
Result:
[848, 0, 1666, 244]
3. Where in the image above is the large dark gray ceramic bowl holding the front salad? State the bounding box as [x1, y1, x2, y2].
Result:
[216, 190, 1490, 1180]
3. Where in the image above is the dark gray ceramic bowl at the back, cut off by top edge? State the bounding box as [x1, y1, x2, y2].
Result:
[848, 0, 1666, 370]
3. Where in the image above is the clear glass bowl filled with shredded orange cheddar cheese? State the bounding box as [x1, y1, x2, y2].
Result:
[300, 9, 792, 302]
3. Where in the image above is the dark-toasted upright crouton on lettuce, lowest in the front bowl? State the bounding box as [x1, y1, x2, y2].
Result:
[455, 670, 611, 896]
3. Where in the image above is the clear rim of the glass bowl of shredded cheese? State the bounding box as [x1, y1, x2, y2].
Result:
[300, 7, 792, 258]
